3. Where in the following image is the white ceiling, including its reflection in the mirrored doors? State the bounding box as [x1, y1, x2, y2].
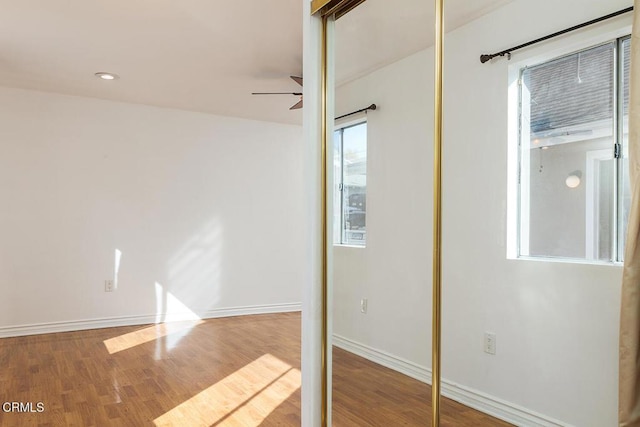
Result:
[0, 0, 511, 124]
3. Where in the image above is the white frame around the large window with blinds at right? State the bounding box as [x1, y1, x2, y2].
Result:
[506, 22, 631, 266]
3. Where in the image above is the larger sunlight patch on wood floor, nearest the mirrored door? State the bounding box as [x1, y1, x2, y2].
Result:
[154, 354, 301, 427]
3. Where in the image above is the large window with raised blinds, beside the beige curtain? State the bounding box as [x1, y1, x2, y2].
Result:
[518, 37, 630, 262]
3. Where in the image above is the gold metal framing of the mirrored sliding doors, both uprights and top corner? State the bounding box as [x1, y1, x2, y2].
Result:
[311, 0, 444, 427]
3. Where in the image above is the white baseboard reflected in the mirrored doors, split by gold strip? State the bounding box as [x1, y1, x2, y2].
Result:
[333, 334, 571, 427]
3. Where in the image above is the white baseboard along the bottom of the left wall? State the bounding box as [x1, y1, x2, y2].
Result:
[0, 303, 302, 338]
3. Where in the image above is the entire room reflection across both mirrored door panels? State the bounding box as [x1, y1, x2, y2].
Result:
[320, 0, 635, 427]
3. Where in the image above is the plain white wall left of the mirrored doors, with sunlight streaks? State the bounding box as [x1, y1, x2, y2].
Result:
[0, 88, 305, 328]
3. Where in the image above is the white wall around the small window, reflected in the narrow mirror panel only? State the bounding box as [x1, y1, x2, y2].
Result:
[333, 46, 432, 361]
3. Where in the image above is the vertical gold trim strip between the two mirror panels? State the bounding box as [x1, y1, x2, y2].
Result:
[431, 0, 444, 427]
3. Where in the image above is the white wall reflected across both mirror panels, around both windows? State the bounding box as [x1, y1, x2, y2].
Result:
[333, 0, 630, 427]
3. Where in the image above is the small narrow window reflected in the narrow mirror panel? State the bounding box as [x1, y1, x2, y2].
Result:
[333, 122, 367, 246]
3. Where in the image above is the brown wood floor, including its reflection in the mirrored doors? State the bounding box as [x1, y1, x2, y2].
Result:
[0, 313, 509, 427]
